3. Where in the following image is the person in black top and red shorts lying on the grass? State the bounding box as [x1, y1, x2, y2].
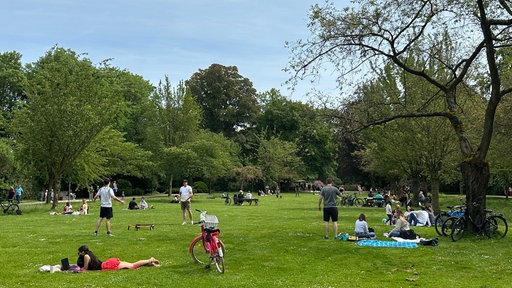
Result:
[76, 245, 160, 272]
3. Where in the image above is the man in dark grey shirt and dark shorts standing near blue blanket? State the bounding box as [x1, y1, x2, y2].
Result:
[318, 178, 341, 240]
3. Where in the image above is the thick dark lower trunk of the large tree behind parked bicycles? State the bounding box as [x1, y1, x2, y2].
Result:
[461, 160, 490, 230]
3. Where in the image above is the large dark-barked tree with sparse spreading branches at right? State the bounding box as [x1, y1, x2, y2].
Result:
[290, 0, 512, 224]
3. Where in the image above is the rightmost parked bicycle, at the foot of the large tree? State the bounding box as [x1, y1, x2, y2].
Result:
[447, 203, 508, 241]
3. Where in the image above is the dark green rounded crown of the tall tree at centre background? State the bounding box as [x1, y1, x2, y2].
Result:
[186, 64, 258, 137]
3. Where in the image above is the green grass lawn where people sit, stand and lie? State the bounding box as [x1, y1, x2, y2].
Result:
[0, 194, 512, 288]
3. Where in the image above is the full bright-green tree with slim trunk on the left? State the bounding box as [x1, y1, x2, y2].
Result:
[15, 47, 122, 208]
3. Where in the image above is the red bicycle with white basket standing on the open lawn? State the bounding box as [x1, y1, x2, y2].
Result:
[188, 209, 226, 273]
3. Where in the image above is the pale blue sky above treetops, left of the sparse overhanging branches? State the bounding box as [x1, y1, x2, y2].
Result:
[0, 0, 348, 101]
